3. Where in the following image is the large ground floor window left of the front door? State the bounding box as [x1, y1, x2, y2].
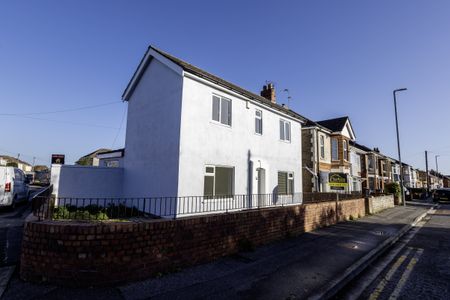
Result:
[203, 166, 234, 197]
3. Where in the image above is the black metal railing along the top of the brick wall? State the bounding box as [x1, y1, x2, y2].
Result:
[33, 193, 363, 220]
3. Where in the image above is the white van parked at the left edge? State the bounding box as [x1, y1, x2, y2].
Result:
[0, 166, 29, 208]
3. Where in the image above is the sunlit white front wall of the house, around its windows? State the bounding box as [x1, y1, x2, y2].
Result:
[176, 76, 302, 203]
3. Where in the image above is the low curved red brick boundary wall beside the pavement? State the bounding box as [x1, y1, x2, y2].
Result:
[20, 199, 365, 286]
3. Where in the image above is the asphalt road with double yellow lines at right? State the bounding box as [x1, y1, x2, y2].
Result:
[343, 204, 450, 300]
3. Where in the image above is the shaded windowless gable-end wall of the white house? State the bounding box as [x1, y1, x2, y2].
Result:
[123, 59, 184, 197]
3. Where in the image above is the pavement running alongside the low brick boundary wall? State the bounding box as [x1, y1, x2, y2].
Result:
[4, 205, 430, 299]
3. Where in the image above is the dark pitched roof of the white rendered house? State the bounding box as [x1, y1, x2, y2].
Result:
[122, 46, 306, 122]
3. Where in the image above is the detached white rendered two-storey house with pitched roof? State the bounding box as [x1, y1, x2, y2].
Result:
[119, 47, 304, 216]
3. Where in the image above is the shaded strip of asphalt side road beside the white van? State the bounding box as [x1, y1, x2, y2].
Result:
[0, 187, 41, 267]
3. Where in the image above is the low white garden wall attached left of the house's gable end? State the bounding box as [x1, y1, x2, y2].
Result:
[51, 165, 123, 198]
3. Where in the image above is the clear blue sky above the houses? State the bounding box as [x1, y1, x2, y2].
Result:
[0, 0, 450, 173]
